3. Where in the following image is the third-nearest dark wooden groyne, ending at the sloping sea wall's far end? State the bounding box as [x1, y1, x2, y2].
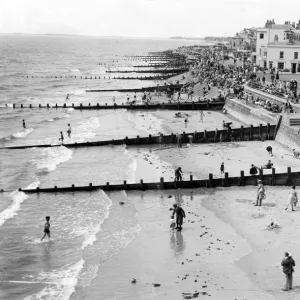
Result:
[5, 101, 225, 110]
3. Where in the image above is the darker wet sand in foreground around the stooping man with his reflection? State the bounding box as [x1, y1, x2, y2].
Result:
[83, 189, 282, 300]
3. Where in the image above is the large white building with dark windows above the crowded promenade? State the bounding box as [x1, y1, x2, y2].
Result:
[253, 20, 300, 73]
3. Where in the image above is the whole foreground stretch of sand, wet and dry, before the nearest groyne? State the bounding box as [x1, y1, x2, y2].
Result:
[81, 187, 300, 300]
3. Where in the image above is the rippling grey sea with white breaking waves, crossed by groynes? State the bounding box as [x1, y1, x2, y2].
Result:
[0, 35, 204, 300]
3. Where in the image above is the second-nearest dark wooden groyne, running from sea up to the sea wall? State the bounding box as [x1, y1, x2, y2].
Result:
[0, 124, 276, 149]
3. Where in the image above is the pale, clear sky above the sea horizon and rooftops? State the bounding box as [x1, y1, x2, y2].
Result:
[0, 0, 300, 37]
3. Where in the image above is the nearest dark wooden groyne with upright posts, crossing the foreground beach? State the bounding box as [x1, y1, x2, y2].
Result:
[15, 167, 300, 195]
